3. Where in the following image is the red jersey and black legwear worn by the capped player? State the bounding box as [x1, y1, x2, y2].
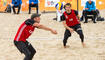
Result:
[14, 19, 36, 60]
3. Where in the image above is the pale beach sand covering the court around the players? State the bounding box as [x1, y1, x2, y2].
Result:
[0, 10, 105, 60]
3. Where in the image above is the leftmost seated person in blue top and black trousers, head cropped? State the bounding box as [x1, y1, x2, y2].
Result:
[12, 0, 22, 14]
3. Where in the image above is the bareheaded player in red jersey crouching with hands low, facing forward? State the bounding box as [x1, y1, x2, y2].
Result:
[61, 3, 84, 48]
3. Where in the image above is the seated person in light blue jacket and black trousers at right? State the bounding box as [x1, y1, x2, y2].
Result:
[80, 0, 99, 23]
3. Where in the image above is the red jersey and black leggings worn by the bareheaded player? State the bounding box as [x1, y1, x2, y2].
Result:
[61, 10, 84, 46]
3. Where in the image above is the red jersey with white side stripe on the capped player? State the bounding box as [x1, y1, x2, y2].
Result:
[14, 19, 35, 42]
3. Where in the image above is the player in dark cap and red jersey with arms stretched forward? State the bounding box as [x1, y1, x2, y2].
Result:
[14, 14, 57, 60]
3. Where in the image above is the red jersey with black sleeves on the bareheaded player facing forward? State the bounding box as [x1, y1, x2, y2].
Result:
[61, 10, 79, 26]
